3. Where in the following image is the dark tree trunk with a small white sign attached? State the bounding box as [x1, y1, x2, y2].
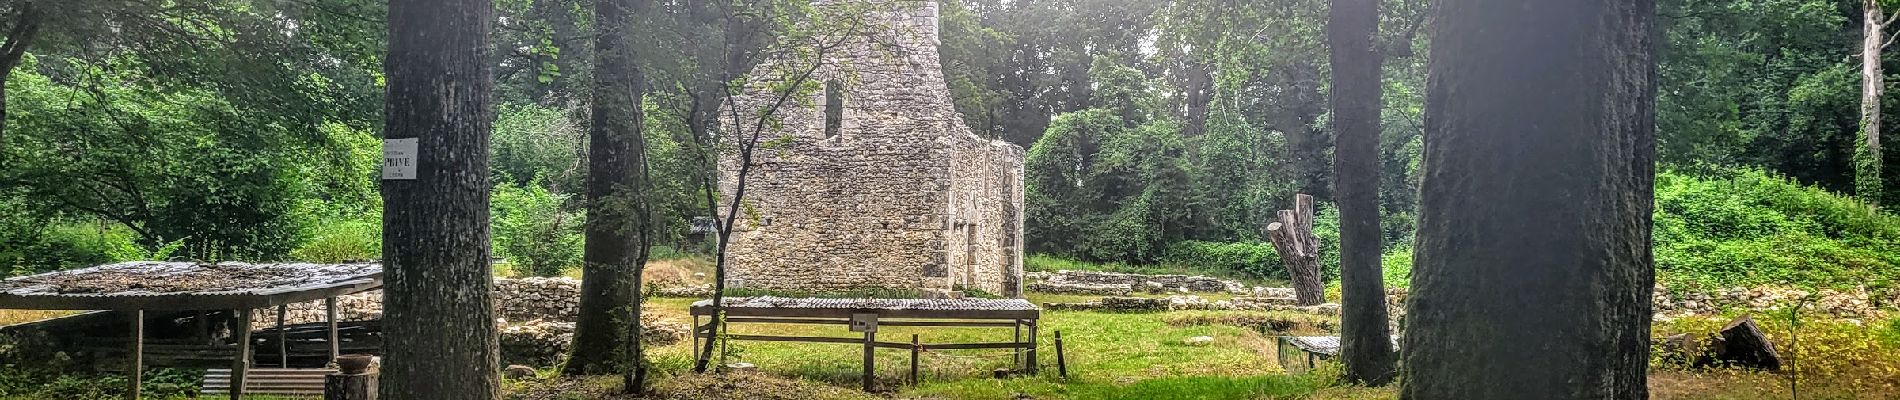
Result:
[380, 0, 502, 400]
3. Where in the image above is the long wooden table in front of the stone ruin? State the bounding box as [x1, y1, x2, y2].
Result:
[692, 296, 1041, 391]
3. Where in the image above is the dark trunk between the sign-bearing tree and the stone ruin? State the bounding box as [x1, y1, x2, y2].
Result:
[564, 0, 646, 373]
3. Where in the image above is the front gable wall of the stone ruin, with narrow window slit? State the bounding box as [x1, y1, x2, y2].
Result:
[720, 2, 961, 290]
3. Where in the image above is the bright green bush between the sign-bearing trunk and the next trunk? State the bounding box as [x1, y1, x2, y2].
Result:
[490, 182, 585, 277]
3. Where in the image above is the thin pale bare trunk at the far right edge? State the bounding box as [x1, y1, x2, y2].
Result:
[1854, 0, 1887, 205]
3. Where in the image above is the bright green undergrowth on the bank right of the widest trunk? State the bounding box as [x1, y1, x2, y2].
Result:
[1653, 171, 1900, 288]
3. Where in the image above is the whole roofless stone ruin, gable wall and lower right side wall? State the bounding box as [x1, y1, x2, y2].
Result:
[720, 0, 1024, 296]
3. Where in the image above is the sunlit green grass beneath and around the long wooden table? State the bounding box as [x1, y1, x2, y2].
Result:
[630, 294, 1317, 398]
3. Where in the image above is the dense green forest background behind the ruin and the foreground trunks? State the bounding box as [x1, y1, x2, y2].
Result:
[0, 0, 1900, 293]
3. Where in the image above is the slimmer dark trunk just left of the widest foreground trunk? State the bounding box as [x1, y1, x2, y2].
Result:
[1326, 0, 1398, 385]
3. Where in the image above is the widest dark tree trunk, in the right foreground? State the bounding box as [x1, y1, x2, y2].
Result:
[1400, 0, 1655, 400]
